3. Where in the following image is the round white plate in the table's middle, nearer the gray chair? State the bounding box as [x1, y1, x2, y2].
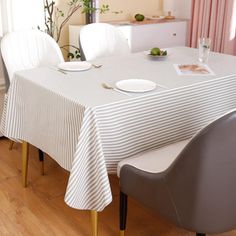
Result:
[116, 79, 156, 93]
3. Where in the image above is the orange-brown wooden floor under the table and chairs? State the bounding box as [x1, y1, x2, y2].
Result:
[0, 138, 236, 236]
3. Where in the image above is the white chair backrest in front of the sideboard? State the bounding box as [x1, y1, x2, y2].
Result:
[79, 23, 130, 60]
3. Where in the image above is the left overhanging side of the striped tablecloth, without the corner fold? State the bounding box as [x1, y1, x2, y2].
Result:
[2, 77, 85, 170]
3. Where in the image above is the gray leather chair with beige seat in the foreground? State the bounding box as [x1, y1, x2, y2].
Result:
[118, 111, 236, 236]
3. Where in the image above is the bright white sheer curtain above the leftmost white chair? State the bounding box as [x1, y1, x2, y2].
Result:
[0, 0, 44, 34]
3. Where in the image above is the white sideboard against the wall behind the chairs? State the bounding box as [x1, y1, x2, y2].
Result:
[69, 20, 188, 56]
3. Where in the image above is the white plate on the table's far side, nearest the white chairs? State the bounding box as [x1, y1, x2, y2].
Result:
[57, 61, 92, 71]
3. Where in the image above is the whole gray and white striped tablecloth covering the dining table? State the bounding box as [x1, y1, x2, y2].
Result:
[2, 48, 236, 211]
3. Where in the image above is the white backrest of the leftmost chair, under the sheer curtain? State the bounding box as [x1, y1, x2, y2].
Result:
[1, 30, 64, 81]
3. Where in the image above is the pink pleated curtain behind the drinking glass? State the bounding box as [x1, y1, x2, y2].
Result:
[189, 0, 236, 55]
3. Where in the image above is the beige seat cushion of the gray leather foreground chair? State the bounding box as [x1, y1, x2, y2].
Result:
[117, 139, 190, 177]
